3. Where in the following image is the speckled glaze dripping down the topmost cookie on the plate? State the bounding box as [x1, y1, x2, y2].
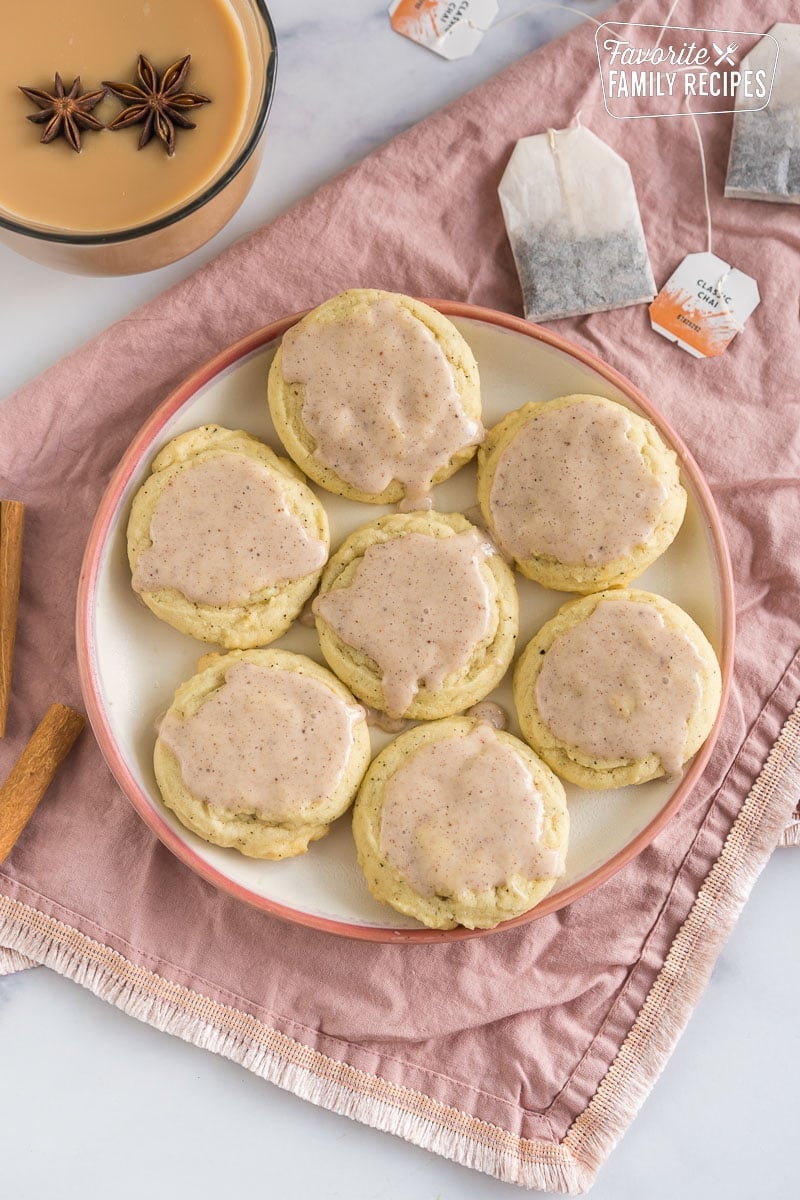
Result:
[282, 298, 483, 508]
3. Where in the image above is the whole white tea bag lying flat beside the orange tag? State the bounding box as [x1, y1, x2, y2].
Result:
[499, 126, 656, 320]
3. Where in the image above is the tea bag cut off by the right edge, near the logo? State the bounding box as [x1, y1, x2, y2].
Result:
[724, 24, 800, 204]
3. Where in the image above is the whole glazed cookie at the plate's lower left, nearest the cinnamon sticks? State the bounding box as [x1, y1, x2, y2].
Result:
[154, 650, 369, 858]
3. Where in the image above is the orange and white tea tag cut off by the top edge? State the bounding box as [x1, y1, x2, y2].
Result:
[389, 0, 498, 59]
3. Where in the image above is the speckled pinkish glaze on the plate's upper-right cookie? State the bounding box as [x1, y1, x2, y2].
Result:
[489, 401, 667, 564]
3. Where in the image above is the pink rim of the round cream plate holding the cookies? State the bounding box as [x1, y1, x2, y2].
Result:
[76, 300, 735, 943]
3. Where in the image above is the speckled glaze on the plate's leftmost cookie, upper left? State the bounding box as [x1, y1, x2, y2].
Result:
[133, 454, 327, 605]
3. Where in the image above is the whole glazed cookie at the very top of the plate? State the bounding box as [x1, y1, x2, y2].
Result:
[267, 288, 483, 511]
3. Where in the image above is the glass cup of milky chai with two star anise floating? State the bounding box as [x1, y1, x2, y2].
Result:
[0, 0, 275, 272]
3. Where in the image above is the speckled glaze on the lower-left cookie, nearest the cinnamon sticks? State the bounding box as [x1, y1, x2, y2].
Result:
[158, 662, 363, 821]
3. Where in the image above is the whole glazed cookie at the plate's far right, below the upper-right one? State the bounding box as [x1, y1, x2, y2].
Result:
[513, 589, 722, 790]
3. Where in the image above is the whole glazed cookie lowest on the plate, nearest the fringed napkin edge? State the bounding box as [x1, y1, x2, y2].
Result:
[353, 716, 570, 929]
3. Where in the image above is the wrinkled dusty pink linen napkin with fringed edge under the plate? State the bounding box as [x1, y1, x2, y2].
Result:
[0, 0, 800, 1192]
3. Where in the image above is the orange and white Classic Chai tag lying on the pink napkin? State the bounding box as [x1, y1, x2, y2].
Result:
[650, 251, 760, 359]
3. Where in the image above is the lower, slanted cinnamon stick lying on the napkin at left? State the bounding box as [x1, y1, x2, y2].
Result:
[0, 704, 85, 863]
